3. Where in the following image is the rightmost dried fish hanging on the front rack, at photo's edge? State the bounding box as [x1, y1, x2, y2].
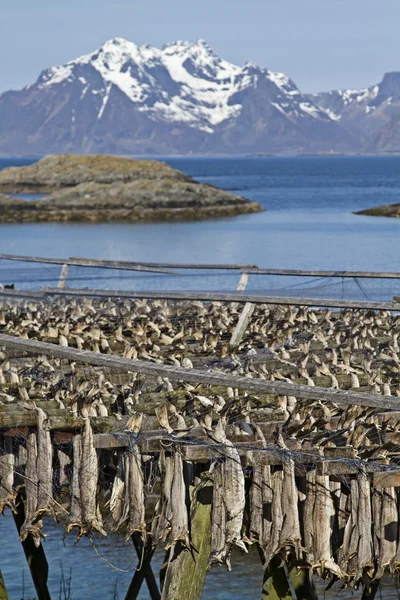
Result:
[372, 487, 399, 579]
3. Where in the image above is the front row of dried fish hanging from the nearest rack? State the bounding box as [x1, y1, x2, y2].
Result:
[0, 409, 400, 584]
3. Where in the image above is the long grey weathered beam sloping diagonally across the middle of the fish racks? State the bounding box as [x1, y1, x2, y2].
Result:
[0, 334, 400, 412]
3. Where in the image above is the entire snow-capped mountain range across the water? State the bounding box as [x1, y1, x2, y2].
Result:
[0, 38, 400, 155]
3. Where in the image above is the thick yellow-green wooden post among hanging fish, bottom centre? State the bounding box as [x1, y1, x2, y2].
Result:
[161, 473, 213, 600]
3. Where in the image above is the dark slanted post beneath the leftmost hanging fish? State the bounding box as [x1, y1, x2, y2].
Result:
[13, 494, 51, 600]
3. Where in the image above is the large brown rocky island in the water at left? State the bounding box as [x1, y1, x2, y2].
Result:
[0, 154, 263, 223]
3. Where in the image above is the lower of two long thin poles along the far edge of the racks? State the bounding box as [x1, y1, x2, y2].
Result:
[41, 287, 400, 312]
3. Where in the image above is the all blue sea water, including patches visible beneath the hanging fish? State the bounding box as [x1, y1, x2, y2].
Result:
[0, 157, 400, 600]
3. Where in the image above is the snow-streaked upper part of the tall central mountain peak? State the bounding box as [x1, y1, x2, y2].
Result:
[38, 38, 330, 133]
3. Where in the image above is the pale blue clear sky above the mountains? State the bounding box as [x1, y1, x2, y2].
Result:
[0, 0, 400, 92]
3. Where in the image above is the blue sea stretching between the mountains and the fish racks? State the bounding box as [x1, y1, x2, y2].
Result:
[0, 157, 400, 299]
